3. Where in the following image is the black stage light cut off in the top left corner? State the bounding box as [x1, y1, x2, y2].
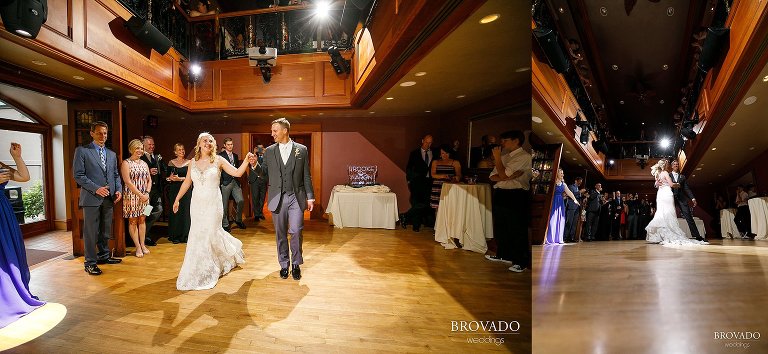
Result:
[0, 0, 48, 38]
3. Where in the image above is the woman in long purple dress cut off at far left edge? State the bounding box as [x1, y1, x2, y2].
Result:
[0, 143, 45, 328]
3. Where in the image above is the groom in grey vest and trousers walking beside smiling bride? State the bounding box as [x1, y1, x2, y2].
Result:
[260, 118, 315, 280]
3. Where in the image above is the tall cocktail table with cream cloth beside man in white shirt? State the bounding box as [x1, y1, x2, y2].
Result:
[435, 183, 493, 253]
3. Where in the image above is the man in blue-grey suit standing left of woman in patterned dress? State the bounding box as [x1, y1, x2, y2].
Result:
[72, 121, 123, 275]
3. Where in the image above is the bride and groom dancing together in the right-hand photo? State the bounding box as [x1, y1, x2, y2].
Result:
[645, 159, 707, 245]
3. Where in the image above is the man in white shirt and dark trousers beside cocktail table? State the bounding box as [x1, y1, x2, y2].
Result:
[486, 130, 531, 273]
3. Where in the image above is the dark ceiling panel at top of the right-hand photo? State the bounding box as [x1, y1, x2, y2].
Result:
[546, 0, 717, 141]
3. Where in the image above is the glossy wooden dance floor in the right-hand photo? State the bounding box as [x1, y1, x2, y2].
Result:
[533, 240, 768, 353]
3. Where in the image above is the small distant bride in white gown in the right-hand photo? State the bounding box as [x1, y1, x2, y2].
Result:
[645, 159, 708, 245]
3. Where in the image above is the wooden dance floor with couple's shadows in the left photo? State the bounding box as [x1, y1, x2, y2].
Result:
[11, 219, 531, 353]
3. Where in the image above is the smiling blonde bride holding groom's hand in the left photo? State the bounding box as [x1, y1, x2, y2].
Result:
[173, 133, 252, 290]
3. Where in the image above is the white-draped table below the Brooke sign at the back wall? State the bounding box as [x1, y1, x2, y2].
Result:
[326, 185, 398, 230]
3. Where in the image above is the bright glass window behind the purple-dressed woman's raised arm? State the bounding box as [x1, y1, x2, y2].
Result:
[0, 129, 47, 224]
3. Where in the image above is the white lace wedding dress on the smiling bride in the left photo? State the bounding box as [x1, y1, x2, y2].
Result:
[176, 156, 245, 290]
